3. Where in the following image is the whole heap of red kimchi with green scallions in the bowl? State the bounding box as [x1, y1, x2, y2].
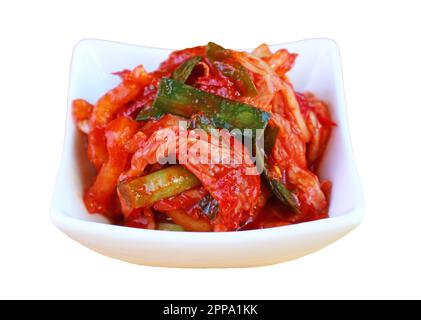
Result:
[72, 42, 335, 232]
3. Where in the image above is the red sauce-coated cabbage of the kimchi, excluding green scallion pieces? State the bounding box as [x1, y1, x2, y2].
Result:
[72, 45, 335, 231]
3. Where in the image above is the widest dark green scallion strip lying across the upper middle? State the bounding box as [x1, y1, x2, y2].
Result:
[137, 78, 270, 138]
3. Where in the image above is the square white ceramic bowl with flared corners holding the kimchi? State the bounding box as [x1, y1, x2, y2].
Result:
[51, 39, 364, 267]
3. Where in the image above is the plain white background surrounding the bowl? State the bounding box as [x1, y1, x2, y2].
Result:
[0, 0, 421, 299]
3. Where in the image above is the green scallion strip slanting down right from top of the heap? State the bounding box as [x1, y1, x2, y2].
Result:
[206, 42, 258, 97]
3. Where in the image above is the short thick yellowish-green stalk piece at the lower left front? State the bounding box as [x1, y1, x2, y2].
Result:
[118, 165, 200, 208]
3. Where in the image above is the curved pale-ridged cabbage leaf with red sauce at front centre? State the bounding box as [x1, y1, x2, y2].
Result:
[121, 127, 260, 231]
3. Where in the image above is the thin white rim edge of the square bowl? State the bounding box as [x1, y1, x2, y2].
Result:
[50, 37, 365, 241]
